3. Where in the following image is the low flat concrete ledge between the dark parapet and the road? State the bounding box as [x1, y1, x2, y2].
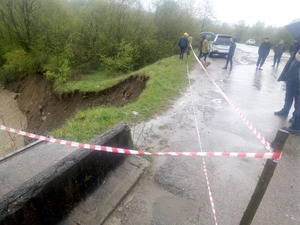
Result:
[59, 156, 149, 225]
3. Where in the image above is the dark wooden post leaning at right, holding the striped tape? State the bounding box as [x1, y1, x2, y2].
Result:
[240, 130, 289, 225]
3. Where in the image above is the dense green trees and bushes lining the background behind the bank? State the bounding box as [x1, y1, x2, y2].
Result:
[0, 0, 292, 85]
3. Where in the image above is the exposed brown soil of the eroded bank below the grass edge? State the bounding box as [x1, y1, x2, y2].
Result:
[13, 75, 149, 134]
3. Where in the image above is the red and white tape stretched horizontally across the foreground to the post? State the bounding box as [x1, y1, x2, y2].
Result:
[0, 125, 281, 160]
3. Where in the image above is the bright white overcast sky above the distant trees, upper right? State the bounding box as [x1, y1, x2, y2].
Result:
[212, 0, 300, 27]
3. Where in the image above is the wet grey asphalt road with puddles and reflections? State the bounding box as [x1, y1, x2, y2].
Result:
[105, 44, 300, 225]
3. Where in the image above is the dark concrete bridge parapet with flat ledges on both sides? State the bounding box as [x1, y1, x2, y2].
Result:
[0, 123, 148, 225]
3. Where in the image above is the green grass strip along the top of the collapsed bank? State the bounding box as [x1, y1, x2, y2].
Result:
[50, 56, 195, 142]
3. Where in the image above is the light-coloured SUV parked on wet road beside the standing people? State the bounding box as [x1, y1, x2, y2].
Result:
[209, 34, 233, 57]
